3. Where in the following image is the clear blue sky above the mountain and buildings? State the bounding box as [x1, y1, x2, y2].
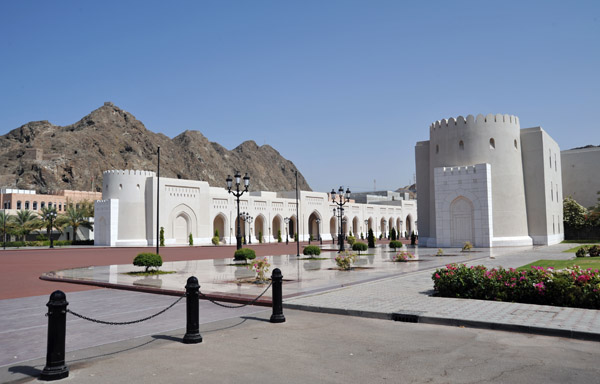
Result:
[0, 0, 600, 191]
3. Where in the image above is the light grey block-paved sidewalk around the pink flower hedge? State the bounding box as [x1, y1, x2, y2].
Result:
[284, 244, 600, 341]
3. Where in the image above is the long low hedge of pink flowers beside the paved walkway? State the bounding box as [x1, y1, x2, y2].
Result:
[431, 264, 600, 309]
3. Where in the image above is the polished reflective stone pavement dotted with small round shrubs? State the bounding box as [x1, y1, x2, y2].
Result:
[43, 246, 518, 301]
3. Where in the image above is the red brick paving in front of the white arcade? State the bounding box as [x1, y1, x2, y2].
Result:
[0, 241, 412, 300]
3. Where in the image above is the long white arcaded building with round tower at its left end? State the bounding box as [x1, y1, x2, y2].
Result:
[94, 170, 417, 246]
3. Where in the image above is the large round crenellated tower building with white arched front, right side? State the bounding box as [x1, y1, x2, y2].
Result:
[415, 114, 564, 247]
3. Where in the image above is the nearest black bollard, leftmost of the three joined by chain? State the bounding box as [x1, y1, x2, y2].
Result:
[40, 291, 69, 381]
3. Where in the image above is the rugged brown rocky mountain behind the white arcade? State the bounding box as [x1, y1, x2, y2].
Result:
[0, 102, 311, 193]
